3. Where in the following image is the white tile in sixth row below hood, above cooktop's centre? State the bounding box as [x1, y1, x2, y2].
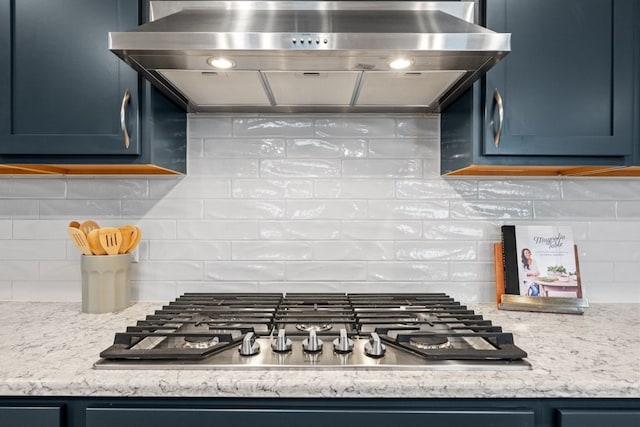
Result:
[260, 220, 340, 240]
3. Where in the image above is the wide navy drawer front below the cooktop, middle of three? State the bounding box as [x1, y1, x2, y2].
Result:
[87, 408, 535, 427]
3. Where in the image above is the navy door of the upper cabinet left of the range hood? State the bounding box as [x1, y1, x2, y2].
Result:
[0, 0, 140, 155]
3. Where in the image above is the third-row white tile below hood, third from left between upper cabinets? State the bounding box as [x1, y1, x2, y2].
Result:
[342, 159, 422, 178]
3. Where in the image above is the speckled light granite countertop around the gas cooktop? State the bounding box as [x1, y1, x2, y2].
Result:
[0, 302, 640, 398]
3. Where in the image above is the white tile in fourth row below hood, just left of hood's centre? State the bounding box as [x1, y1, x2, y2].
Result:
[231, 179, 313, 199]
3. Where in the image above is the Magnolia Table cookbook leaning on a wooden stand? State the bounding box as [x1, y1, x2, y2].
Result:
[502, 225, 582, 298]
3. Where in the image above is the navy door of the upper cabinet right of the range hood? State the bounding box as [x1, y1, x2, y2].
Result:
[483, 0, 637, 156]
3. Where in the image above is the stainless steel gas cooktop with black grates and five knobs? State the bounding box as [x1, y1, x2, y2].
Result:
[94, 293, 530, 370]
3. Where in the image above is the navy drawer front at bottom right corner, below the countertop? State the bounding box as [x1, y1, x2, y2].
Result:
[558, 409, 640, 427]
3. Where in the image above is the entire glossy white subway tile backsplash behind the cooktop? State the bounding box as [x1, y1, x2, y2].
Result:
[0, 114, 640, 303]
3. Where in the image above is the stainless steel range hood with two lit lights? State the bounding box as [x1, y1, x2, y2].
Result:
[109, 1, 510, 112]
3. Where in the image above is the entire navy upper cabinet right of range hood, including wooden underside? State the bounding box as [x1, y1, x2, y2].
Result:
[442, 0, 639, 175]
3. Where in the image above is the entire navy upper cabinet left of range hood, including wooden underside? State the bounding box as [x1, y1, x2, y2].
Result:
[0, 0, 186, 173]
